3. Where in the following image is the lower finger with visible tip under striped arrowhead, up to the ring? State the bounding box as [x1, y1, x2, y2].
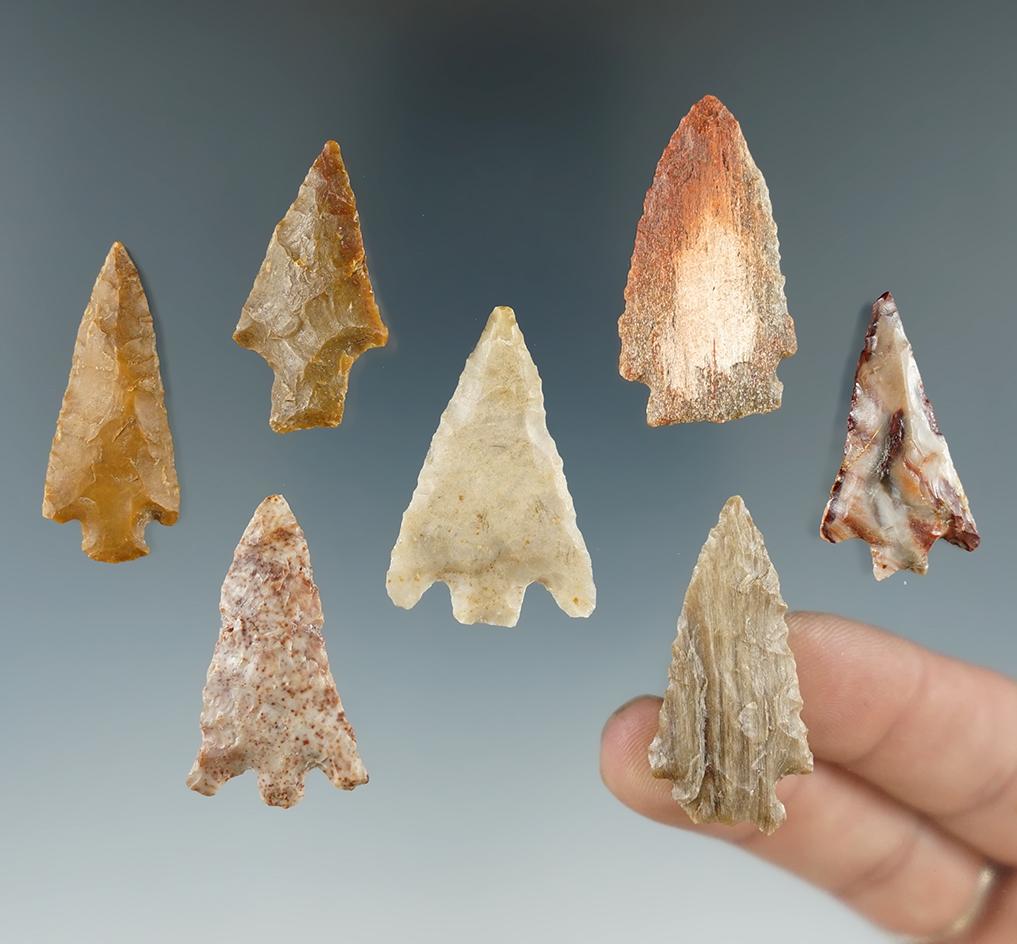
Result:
[601, 696, 985, 936]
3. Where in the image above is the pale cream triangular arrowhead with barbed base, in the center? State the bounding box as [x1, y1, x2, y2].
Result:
[386, 308, 596, 627]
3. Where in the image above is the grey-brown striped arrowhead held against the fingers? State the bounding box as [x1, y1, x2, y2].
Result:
[649, 496, 813, 833]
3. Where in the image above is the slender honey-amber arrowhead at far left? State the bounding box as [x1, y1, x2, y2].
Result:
[43, 242, 180, 563]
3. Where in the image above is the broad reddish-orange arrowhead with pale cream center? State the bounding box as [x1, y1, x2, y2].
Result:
[618, 96, 797, 426]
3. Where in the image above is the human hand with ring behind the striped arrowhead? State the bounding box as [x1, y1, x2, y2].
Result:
[600, 613, 1017, 944]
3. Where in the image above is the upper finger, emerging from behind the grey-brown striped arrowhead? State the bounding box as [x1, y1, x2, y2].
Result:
[788, 613, 1017, 865]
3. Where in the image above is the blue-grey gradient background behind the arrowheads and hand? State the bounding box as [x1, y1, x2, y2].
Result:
[0, 3, 1017, 944]
